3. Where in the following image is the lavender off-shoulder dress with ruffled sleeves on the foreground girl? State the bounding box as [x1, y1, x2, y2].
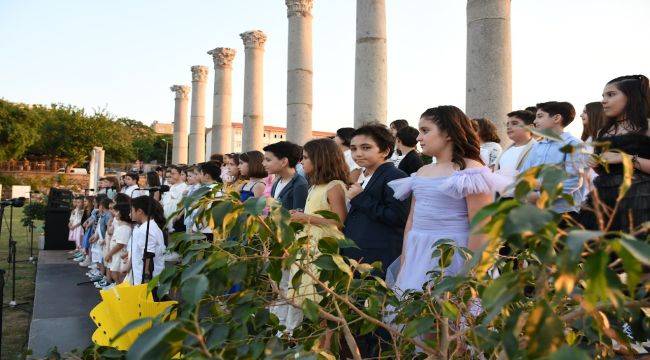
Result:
[387, 167, 511, 294]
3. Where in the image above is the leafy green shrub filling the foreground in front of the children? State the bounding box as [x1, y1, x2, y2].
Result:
[93, 145, 650, 359]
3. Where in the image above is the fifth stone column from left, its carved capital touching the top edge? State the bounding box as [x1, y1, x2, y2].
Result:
[285, 0, 314, 145]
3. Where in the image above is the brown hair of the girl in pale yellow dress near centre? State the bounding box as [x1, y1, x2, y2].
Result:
[302, 138, 350, 185]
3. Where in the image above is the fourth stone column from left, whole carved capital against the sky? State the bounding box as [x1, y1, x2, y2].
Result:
[239, 30, 266, 151]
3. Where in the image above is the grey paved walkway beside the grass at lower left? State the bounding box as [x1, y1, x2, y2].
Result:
[28, 250, 100, 357]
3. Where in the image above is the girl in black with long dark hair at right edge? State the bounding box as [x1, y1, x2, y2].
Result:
[580, 75, 650, 232]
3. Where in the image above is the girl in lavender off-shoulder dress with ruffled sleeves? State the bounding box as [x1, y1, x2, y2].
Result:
[388, 106, 507, 294]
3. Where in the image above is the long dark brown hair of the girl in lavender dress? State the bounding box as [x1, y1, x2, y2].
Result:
[420, 105, 483, 170]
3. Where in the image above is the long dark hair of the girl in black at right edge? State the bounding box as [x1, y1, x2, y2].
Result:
[598, 75, 650, 136]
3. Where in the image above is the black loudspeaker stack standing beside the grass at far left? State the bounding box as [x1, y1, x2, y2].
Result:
[44, 188, 76, 250]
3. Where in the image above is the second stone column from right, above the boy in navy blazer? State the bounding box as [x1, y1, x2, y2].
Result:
[354, 0, 387, 127]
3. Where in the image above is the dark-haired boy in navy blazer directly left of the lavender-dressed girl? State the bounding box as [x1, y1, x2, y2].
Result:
[343, 124, 409, 271]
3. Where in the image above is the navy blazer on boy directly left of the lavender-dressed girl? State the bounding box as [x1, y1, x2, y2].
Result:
[343, 162, 410, 270]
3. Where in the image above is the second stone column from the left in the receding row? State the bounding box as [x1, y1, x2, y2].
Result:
[187, 65, 208, 164]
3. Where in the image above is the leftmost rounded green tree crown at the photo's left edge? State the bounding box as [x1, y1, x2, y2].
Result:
[0, 99, 43, 161]
